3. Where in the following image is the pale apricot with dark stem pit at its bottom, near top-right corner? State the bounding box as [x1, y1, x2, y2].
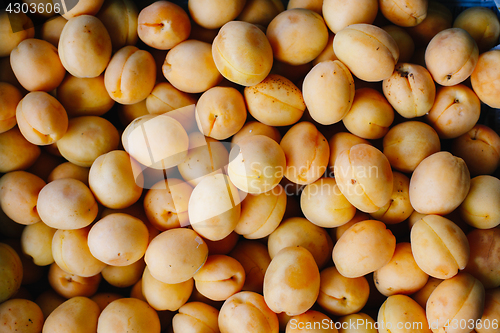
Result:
[425, 28, 479, 86]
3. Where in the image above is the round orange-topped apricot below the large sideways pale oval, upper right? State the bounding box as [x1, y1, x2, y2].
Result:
[342, 88, 394, 139]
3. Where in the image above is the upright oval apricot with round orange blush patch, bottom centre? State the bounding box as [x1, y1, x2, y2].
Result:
[264, 246, 320, 316]
